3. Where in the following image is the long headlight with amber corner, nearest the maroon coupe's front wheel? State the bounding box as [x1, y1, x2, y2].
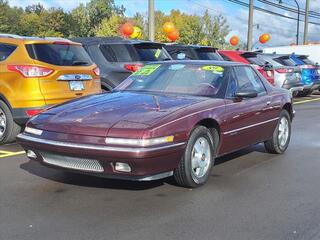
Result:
[106, 136, 174, 147]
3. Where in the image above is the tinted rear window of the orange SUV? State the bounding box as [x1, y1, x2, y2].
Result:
[26, 43, 92, 66]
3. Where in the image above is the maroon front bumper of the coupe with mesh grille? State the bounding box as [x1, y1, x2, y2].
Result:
[17, 133, 186, 181]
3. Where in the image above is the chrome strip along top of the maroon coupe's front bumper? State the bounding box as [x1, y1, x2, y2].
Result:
[17, 133, 186, 153]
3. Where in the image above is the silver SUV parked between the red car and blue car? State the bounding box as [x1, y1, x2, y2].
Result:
[246, 52, 304, 95]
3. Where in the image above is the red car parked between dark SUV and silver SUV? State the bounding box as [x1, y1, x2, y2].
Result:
[218, 50, 275, 85]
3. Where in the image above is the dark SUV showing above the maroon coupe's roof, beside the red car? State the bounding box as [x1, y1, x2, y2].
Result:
[164, 43, 223, 61]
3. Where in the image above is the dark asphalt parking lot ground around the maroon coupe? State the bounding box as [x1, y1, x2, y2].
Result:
[0, 95, 320, 240]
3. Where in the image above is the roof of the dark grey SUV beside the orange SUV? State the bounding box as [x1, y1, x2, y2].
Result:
[70, 37, 164, 45]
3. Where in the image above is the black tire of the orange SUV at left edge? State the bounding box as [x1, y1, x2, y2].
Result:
[0, 101, 21, 145]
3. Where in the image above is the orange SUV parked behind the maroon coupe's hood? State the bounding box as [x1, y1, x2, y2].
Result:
[0, 34, 101, 144]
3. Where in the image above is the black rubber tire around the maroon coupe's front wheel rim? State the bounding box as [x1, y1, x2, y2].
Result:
[174, 126, 219, 188]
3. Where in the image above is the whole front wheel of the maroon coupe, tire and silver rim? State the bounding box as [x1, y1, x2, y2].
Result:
[174, 126, 218, 188]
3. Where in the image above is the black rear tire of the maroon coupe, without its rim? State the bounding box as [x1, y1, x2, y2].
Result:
[264, 110, 291, 154]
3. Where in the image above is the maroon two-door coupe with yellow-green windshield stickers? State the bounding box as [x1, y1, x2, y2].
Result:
[18, 61, 294, 187]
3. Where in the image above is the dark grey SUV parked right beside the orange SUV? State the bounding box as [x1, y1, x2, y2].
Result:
[71, 37, 171, 91]
